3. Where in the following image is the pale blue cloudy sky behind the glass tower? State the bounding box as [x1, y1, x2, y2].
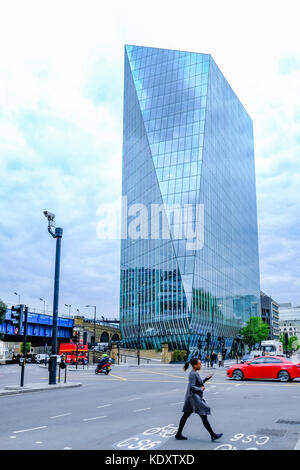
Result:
[0, 0, 300, 318]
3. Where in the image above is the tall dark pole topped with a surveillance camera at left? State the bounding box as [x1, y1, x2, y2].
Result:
[44, 211, 63, 385]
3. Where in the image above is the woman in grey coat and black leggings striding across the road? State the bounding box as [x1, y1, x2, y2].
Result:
[175, 357, 223, 441]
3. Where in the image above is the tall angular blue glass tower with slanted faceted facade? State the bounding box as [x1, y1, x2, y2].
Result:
[120, 45, 260, 351]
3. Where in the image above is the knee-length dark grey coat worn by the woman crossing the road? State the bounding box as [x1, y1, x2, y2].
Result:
[182, 369, 210, 415]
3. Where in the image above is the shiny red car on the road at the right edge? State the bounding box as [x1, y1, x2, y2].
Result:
[227, 356, 300, 382]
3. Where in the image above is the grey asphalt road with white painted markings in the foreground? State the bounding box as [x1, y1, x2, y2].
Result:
[0, 364, 300, 450]
